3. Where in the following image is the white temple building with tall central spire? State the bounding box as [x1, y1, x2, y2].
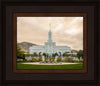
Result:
[29, 25, 71, 57]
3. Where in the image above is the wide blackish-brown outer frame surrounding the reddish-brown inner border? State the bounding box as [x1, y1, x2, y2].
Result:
[2, 2, 98, 85]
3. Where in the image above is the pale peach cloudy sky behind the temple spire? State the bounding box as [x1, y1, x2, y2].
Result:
[17, 17, 83, 50]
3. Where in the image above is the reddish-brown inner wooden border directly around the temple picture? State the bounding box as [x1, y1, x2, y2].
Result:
[13, 13, 87, 73]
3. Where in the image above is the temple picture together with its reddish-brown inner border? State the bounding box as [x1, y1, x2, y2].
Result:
[13, 13, 87, 73]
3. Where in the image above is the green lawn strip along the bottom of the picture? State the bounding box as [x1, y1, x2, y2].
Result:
[17, 63, 83, 69]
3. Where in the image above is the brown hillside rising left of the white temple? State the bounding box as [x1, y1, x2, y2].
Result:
[18, 42, 36, 52]
